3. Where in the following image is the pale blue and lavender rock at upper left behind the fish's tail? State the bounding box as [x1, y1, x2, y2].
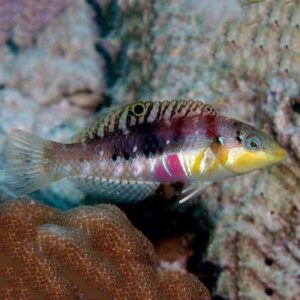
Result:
[0, 0, 104, 207]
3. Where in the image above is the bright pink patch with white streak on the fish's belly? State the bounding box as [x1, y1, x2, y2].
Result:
[154, 154, 186, 182]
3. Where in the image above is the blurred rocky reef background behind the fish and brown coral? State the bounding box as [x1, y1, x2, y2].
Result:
[0, 0, 300, 300]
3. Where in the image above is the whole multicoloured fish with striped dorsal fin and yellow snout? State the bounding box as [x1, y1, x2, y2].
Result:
[5, 99, 287, 203]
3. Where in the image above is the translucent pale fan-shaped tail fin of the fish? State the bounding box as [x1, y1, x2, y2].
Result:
[5, 129, 62, 195]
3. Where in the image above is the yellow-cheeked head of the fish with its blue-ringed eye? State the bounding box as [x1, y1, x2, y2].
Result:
[214, 119, 287, 175]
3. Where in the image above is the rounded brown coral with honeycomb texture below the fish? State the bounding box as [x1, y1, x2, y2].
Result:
[0, 199, 210, 300]
